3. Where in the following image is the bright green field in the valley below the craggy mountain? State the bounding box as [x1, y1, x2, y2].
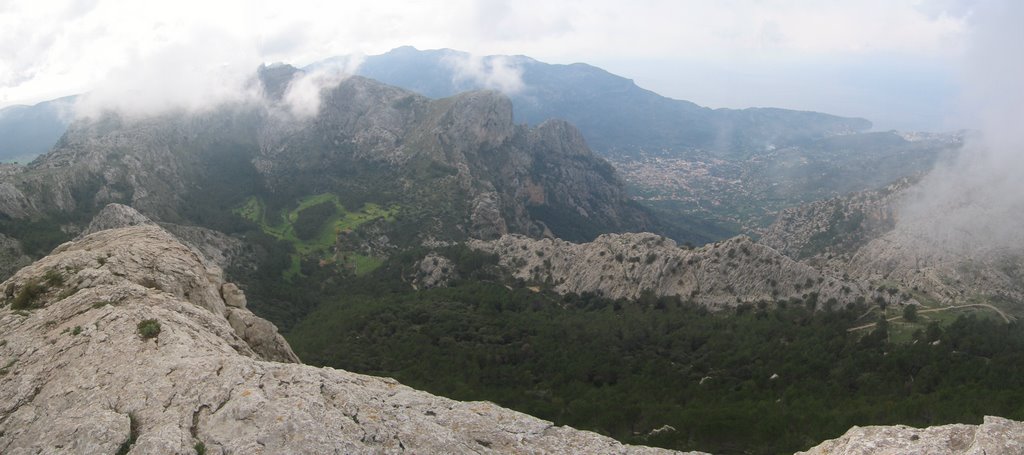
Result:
[234, 194, 398, 279]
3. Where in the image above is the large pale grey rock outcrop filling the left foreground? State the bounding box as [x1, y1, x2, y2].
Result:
[0, 215, 696, 454]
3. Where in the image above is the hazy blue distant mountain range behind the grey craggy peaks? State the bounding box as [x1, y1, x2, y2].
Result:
[0, 46, 871, 160]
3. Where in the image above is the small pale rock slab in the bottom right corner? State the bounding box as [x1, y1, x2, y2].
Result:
[800, 417, 1024, 455]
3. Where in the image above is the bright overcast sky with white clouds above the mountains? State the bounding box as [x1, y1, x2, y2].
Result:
[0, 0, 983, 130]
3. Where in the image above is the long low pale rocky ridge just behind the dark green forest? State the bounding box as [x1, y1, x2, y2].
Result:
[469, 230, 869, 308]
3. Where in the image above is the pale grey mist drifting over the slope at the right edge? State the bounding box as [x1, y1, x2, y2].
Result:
[898, 1, 1024, 253]
